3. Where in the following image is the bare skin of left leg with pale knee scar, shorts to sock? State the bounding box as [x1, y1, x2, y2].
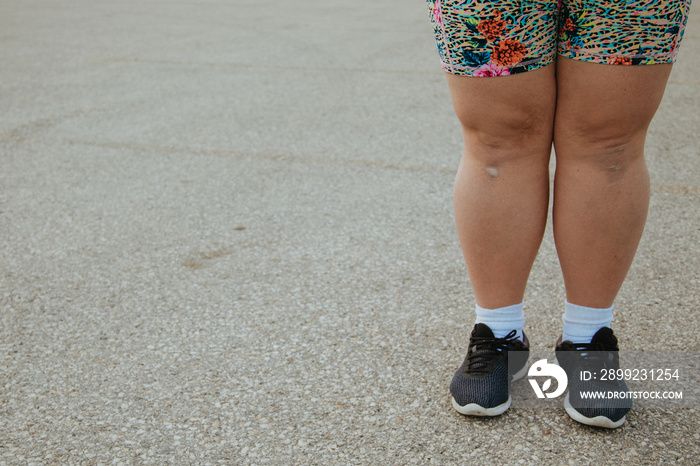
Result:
[447, 65, 556, 309]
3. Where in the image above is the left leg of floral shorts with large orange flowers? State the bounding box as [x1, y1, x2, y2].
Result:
[427, 0, 557, 77]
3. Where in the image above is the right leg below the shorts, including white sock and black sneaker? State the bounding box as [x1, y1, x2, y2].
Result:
[553, 57, 671, 428]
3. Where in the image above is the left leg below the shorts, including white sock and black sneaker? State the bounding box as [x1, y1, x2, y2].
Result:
[447, 65, 556, 416]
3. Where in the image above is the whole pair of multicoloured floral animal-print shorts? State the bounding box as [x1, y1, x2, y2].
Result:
[427, 0, 691, 76]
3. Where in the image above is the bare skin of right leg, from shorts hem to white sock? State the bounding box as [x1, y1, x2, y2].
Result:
[553, 57, 671, 308]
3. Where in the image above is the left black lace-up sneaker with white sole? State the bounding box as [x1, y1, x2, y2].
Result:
[450, 324, 530, 416]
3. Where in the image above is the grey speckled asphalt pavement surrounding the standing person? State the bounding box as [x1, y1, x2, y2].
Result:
[0, 0, 700, 464]
